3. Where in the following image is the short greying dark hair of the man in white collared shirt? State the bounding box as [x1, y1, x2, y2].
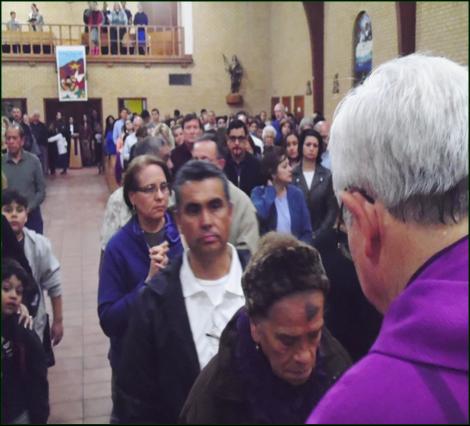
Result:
[173, 160, 230, 209]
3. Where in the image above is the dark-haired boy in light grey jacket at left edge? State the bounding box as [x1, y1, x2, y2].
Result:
[2, 189, 63, 365]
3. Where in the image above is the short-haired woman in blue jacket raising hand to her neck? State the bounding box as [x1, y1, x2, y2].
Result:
[251, 146, 312, 244]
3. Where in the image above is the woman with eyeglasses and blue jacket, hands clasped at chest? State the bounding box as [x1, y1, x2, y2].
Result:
[98, 155, 183, 421]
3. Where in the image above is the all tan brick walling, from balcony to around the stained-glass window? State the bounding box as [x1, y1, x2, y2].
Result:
[2, 2, 468, 119]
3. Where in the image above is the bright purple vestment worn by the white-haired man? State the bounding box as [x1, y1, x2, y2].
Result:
[307, 236, 468, 424]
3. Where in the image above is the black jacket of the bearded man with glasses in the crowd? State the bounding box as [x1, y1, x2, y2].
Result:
[224, 152, 264, 197]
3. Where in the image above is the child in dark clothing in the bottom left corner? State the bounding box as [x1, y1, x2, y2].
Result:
[1, 258, 49, 424]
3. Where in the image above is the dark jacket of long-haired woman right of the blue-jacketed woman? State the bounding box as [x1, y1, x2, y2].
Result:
[292, 163, 339, 246]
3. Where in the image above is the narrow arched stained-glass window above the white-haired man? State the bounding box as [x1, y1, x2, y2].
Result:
[354, 12, 372, 85]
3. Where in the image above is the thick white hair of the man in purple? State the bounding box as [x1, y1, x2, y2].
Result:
[329, 54, 468, 224]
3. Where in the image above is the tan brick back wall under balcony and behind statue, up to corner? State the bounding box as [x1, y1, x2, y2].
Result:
[2, 2, 270, 116]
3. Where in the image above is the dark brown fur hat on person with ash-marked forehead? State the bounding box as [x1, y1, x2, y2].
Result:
[242, 232, 329, 318]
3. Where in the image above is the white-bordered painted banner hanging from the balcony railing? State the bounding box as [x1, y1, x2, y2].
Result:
[56, 46, 88, 102]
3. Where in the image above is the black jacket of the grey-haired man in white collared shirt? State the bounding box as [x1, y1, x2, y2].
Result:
[115, 250, 249, 423]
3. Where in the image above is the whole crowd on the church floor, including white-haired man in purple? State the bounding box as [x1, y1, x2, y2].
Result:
[2, 54, 468, 424]
